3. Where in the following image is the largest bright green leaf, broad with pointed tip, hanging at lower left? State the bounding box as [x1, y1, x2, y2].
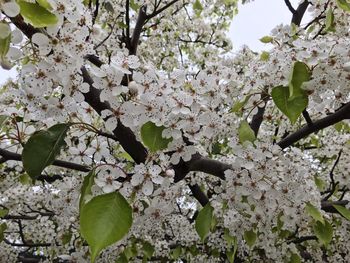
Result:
[80, 192, 132, 262]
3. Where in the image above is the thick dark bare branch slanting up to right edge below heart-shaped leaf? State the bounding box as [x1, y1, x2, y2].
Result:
[278, 102, 350, 149]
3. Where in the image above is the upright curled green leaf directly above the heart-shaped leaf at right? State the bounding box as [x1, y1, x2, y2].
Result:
[289, 61, 311, 98]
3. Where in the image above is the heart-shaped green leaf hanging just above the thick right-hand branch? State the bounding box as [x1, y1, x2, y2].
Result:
[271, 86, 309, 124]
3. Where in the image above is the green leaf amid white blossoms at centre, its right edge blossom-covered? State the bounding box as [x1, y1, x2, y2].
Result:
[141, 121, 172, 152]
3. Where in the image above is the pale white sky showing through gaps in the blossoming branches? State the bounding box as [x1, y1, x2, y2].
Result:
[0, 0, 305, 84]
